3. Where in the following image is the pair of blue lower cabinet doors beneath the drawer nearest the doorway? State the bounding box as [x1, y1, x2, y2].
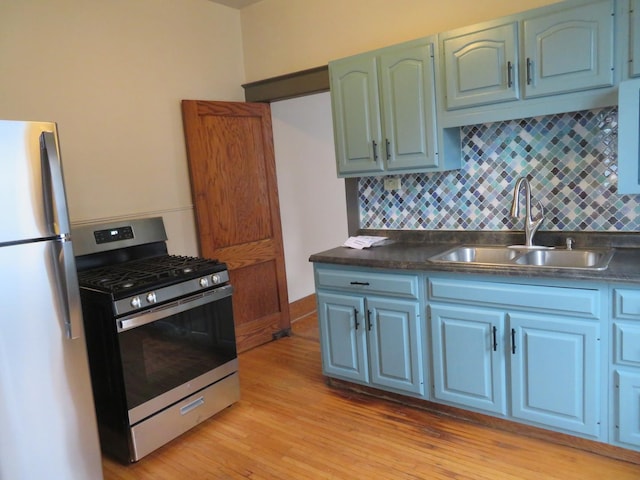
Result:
[317, 284, 424, 396]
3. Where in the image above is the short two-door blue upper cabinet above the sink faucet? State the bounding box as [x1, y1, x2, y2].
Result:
[439, 0, 622, 127]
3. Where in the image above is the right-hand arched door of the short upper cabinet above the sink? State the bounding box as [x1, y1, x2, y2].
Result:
[523, 0, 614, 98]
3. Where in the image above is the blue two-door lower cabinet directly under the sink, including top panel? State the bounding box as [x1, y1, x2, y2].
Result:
[427, 276, 607, 440]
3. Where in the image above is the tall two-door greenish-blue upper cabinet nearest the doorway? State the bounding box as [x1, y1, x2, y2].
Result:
[329, 38, 461, 177]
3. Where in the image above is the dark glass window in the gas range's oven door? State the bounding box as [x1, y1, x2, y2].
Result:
[118, 296, 237, 409]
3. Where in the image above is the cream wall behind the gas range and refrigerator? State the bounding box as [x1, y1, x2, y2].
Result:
[0, 0, 244, 254]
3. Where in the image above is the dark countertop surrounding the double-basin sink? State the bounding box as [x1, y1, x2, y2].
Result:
[309, 230, 640, 283]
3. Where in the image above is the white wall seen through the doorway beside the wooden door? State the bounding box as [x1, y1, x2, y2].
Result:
[271, 92, 347, 302]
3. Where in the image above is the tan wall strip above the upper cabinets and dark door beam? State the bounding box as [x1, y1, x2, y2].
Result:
[242, 0, 558, 82]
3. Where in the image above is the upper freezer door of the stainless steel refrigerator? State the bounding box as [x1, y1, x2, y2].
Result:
[0, 120, 69, 245]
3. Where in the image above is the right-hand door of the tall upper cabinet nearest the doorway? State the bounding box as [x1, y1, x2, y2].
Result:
[380, 44, 438, 171]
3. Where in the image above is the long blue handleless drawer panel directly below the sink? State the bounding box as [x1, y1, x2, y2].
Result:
[429, 278, 601, 319]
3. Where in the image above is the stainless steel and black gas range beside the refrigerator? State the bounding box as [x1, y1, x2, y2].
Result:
[72, 217, 240, 463]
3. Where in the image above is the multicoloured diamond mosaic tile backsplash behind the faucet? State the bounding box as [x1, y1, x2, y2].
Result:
[358, 108, 640, 231]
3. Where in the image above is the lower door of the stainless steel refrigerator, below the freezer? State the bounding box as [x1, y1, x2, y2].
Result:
[0, 241, 103, 480]
